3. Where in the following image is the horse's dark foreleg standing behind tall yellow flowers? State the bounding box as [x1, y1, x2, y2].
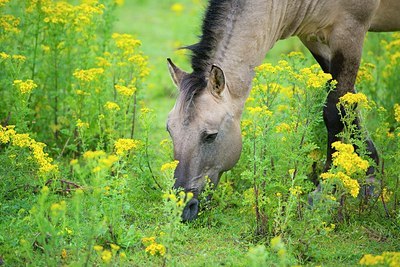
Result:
[301, 23, 379, 175]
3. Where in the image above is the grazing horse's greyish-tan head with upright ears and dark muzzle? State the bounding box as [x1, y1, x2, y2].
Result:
[167, 60, 242, 221]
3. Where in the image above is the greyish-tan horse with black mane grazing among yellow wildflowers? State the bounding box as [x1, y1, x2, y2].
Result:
[167, 0, 400, 221]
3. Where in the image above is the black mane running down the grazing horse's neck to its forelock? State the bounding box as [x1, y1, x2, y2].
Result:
[180, 0, 242, 108]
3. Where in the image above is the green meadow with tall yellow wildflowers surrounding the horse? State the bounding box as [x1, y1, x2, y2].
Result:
[0, 0, 400, 266]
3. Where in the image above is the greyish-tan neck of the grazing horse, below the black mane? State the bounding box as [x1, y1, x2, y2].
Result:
[213, 0, 290, 103]
